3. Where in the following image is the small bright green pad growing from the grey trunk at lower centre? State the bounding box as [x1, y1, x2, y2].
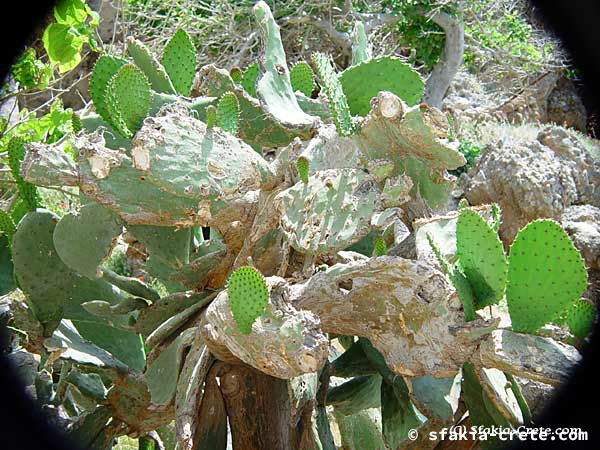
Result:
[227, 266, 269, 334]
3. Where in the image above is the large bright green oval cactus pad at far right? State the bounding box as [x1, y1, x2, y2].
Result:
[506, 219, 587, 333]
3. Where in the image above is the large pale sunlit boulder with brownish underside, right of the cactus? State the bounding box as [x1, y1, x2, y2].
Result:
[461, 127, 599, 243]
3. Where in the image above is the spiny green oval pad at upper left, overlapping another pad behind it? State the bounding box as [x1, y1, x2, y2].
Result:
[106, 64, 152, 136]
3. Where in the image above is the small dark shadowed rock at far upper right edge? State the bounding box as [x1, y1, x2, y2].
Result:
[547, 77, 587, 131]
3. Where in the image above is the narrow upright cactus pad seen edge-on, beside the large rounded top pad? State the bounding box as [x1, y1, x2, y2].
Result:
[312, 52, 356, 136]
